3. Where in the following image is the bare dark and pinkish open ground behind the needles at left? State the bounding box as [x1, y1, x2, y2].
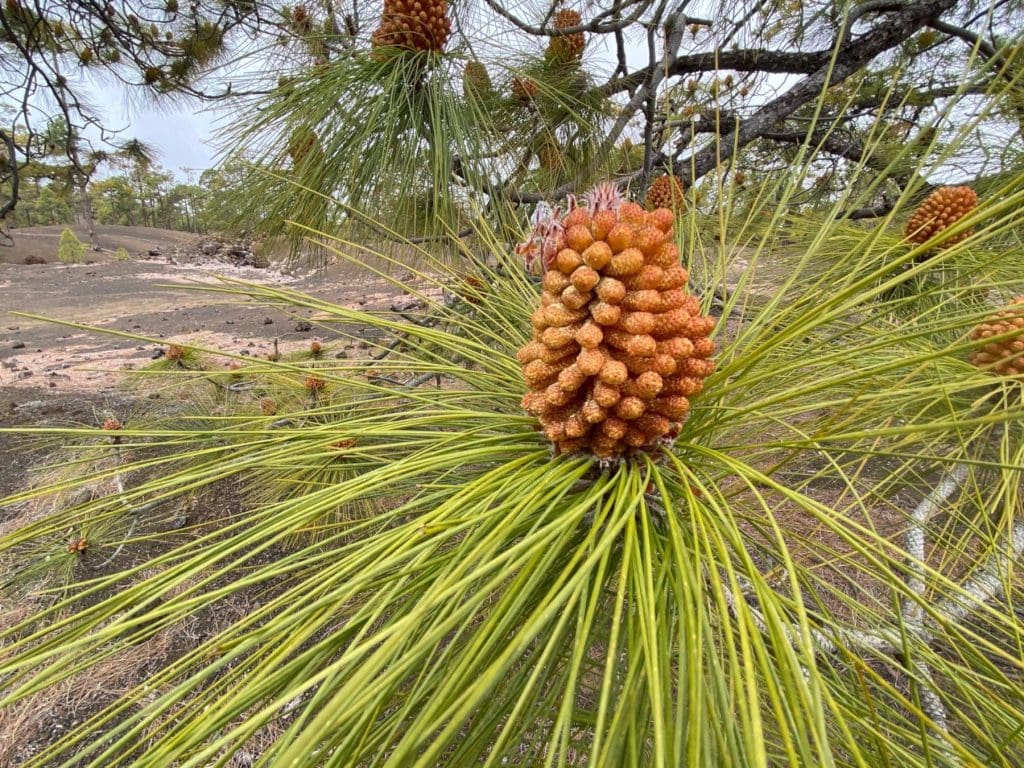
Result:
[0, 227, 415, 499]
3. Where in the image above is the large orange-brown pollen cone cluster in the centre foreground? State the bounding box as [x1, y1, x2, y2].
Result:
[518, 198, 715, 458]
